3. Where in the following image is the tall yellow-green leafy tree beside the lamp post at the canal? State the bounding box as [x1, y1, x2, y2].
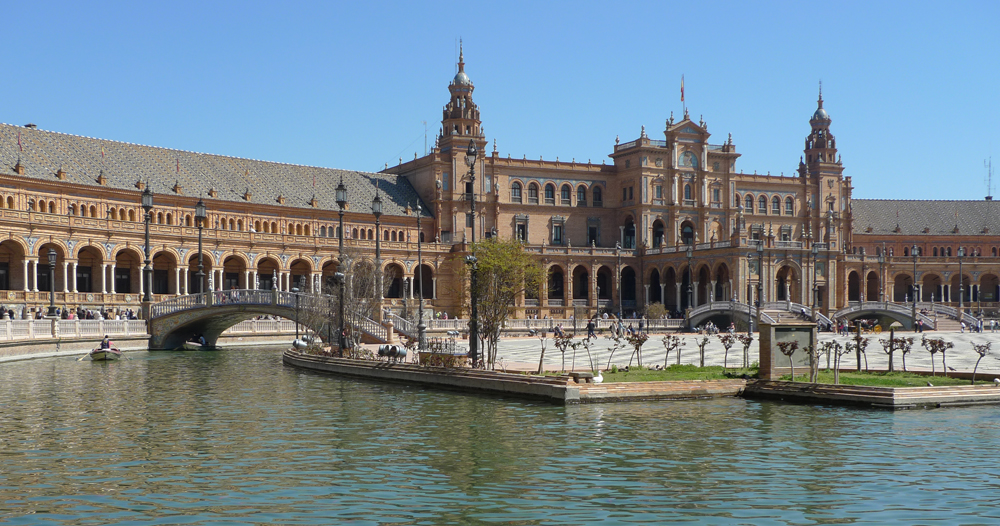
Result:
[462, 237, 544, 367]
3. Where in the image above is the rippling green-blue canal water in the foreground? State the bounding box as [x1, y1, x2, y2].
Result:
[0, 349, 1000, 525]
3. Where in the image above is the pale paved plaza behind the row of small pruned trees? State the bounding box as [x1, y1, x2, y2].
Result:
[488, 332, 1000, 377]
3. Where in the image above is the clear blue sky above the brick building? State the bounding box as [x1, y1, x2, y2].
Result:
[0, 1, 1000, 199]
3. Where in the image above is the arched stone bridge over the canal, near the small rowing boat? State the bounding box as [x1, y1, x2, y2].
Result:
[149, 290, 356, 349]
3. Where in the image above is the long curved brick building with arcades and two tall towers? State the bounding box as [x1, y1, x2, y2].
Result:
[0, 54, 1000, 326]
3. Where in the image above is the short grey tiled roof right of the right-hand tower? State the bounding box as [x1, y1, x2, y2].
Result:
[851, 199, 1000, 236]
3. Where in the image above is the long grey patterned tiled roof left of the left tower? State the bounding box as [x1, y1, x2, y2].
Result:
[0, 124, 429, 217]
